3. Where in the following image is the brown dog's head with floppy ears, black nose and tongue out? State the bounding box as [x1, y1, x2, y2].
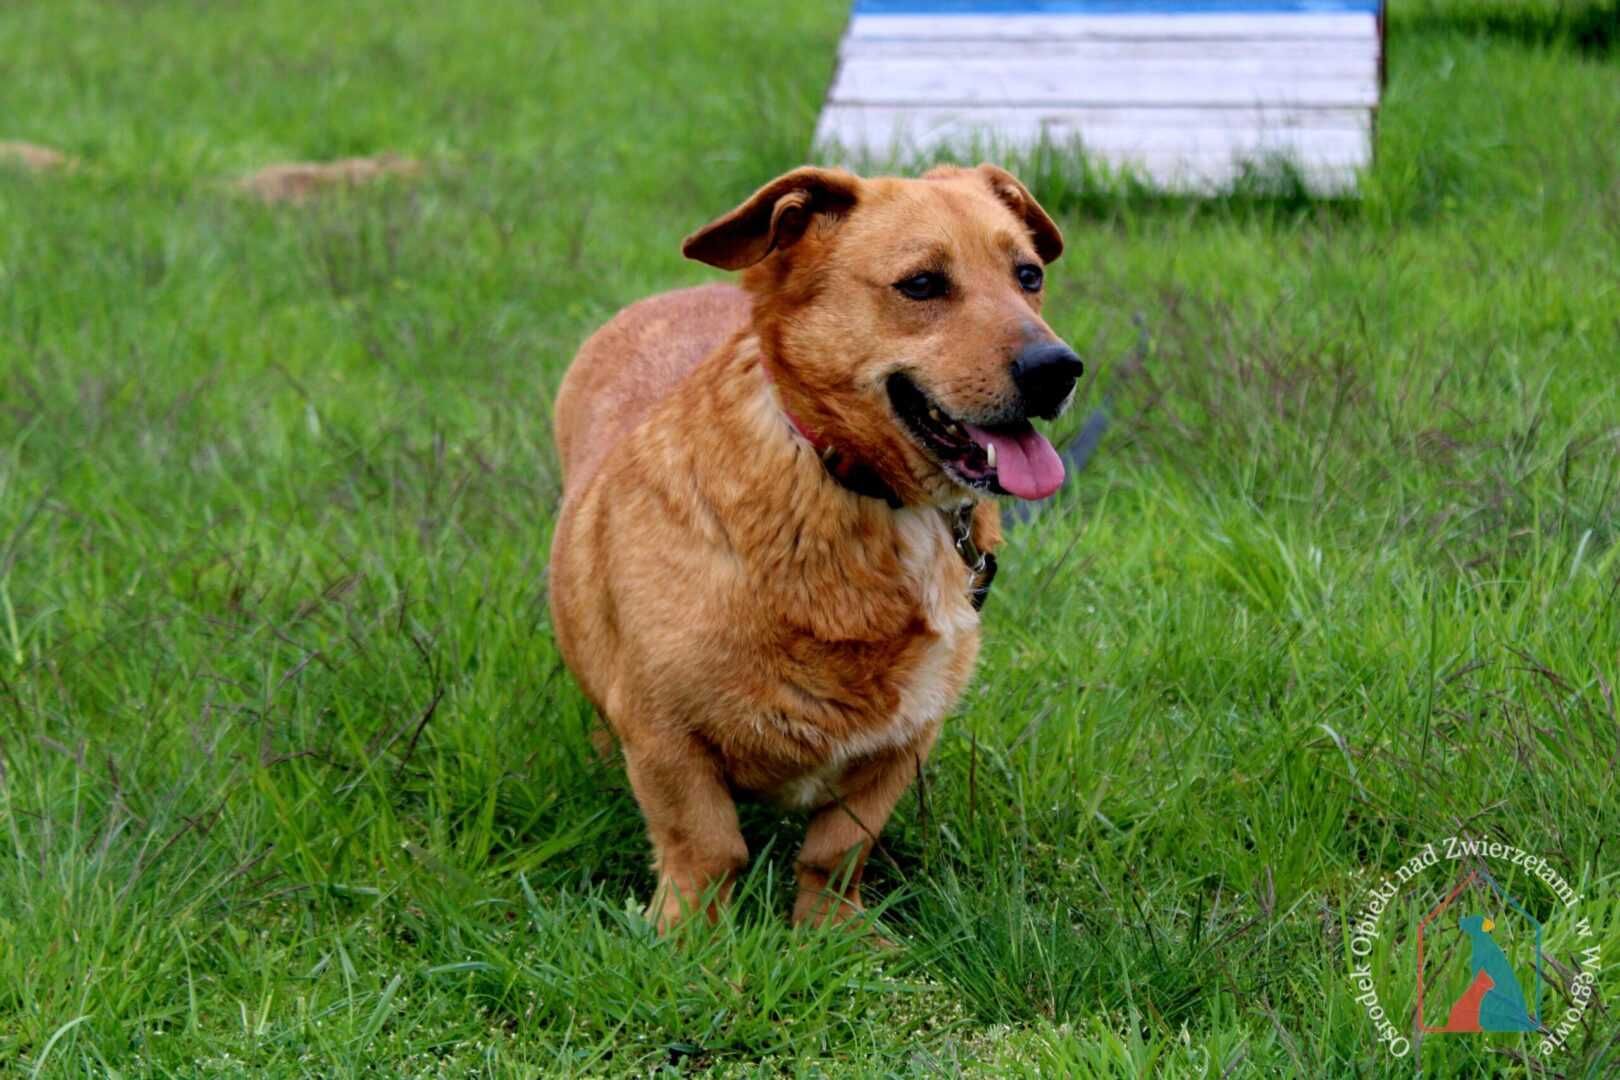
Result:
[684, 165, 1081, 505]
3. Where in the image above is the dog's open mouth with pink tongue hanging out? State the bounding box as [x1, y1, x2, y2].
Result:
[888, 371, 1063, 499]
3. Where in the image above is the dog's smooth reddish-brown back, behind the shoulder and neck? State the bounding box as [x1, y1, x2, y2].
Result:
[556, 285, 750, 491]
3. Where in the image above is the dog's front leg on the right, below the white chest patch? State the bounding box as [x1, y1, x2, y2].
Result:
[794, 744, 933, 926]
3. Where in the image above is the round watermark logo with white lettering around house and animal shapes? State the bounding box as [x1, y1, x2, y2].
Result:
[1348, 837, 1602, 1057]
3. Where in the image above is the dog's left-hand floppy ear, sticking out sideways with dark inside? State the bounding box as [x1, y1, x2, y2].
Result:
[680, 165, 861, 270]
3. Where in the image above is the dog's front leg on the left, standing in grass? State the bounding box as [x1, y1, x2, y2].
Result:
[624, 738, 748, 933]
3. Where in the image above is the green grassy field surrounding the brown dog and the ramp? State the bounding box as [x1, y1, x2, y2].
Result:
[0, 0, 1620, 1077]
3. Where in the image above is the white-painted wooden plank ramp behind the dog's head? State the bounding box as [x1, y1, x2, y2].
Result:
[816, 0, 1383, 194]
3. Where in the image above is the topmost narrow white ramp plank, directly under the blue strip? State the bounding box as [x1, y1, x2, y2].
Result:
[849, 11, 1379, 40]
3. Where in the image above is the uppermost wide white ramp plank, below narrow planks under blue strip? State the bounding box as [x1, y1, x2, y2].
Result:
[828, 60, 1379, 107]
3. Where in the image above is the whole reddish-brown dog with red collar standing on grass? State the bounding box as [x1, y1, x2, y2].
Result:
[551, 165, 1081, 929]
